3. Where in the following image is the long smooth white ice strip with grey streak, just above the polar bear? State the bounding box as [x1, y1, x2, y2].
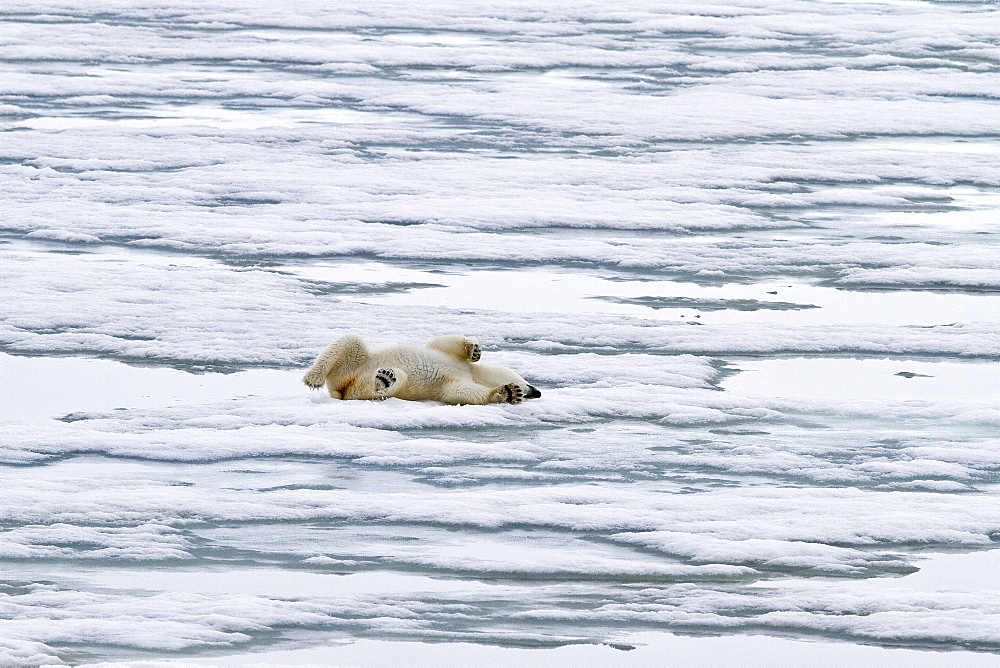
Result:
[283, 261, 1000, 325]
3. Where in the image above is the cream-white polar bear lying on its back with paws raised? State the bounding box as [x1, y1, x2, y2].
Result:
[302, 334, 542, 404]
